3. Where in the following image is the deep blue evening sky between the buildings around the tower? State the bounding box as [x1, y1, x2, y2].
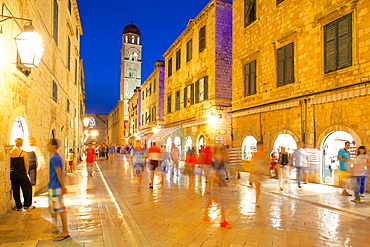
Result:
[77, 0, 227, 114]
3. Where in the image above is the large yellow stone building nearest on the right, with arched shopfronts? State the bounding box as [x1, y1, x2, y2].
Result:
[232, 0, 370, 184]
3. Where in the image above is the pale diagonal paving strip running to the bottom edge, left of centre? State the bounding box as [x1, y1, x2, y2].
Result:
[96, 163, 151, 246]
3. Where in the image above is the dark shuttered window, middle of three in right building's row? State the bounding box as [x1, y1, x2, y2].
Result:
[277, 43, 294, 87]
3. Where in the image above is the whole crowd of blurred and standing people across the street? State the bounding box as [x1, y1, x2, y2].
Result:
[10, 138, 370, 241]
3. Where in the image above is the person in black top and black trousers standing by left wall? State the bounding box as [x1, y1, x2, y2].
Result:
[10, 138, 35, 211]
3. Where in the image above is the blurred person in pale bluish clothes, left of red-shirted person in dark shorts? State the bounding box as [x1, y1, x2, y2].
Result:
[130, 140, 148, 189]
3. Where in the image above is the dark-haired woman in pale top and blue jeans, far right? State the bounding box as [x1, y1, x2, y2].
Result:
[351, 146, 370, 202]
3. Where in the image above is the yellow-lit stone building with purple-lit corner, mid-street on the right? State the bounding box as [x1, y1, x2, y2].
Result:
[161, 0, 232, 154]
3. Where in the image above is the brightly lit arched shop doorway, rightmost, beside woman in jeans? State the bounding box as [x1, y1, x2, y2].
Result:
[321, 131, 356, 184]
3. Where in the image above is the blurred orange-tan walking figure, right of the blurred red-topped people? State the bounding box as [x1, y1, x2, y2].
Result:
[250, 142, 270, 207]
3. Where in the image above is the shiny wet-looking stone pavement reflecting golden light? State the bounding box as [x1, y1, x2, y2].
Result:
[0, 156, 370, 247]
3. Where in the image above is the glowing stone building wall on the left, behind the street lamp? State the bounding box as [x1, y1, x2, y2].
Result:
[0, 0, 85, 214]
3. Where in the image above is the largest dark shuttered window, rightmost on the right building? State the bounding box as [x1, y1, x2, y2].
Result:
[323, 12, 354, 74]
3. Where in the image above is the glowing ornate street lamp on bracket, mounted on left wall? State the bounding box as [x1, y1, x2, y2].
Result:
[0, 15, 44, 68]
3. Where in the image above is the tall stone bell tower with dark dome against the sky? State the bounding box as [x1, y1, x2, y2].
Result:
[120, 20, 142, 121]
